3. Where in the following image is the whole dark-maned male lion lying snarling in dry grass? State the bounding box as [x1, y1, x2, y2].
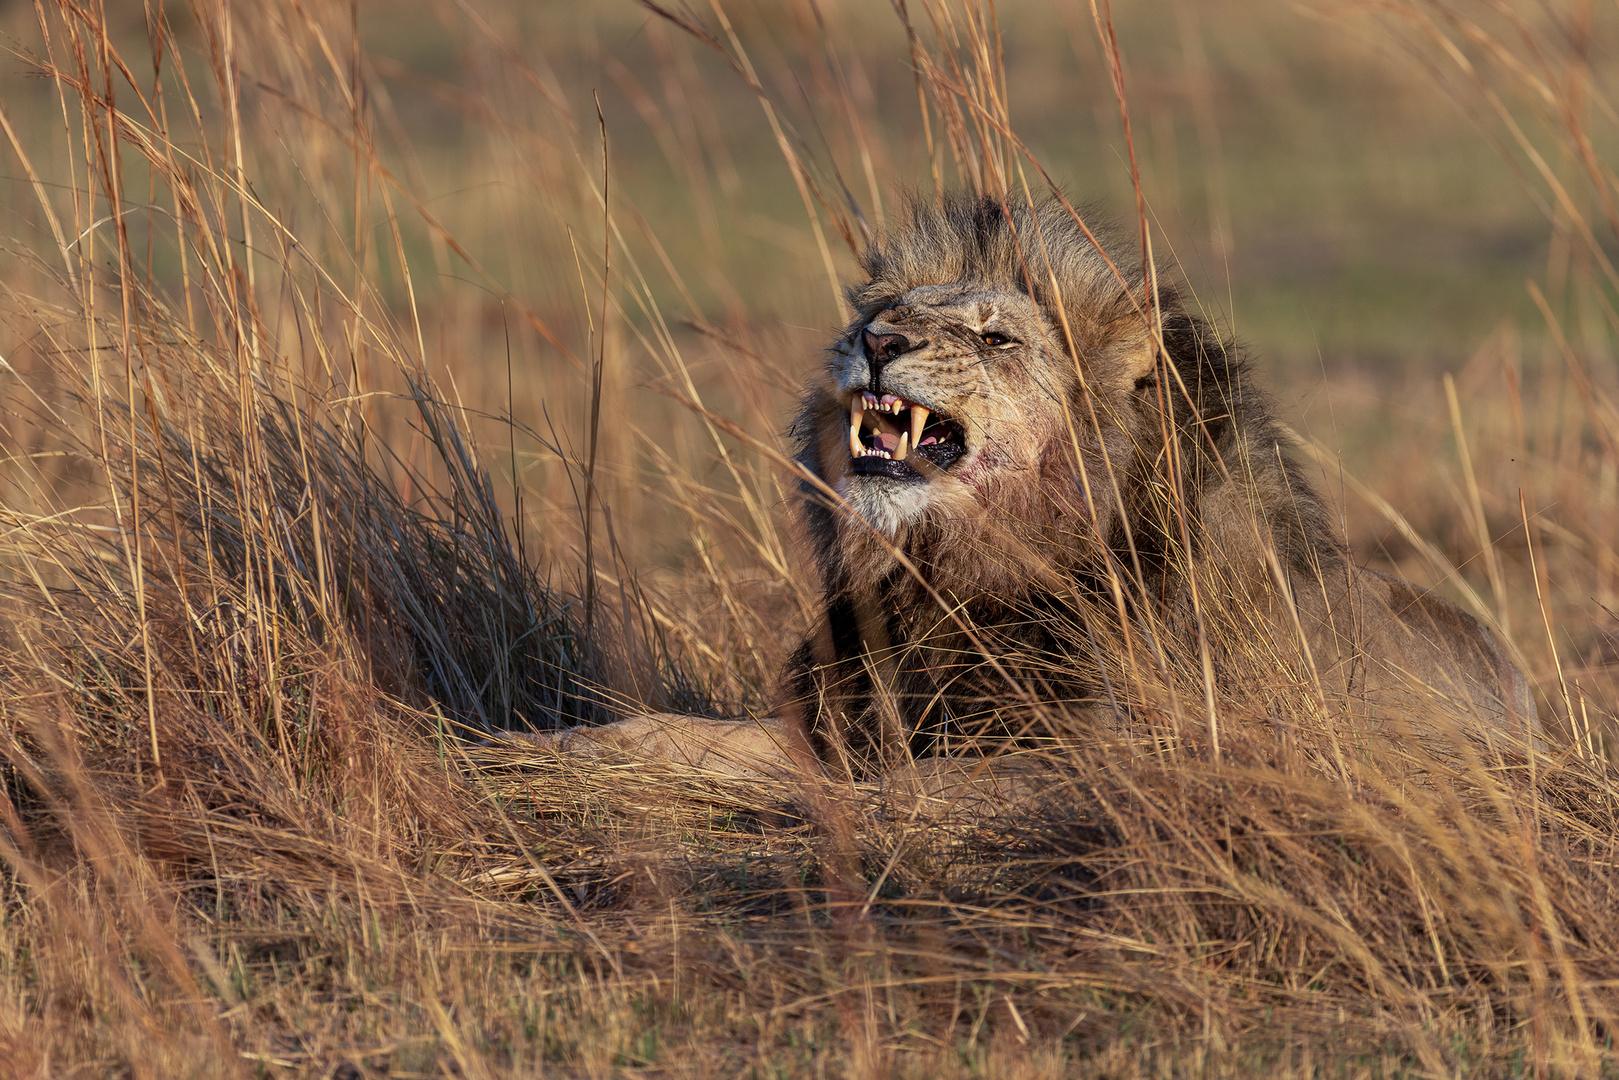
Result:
[544, 194, 1538, 786]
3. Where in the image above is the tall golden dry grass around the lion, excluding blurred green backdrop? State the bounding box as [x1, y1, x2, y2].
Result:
[0, 0, 1619, 1078]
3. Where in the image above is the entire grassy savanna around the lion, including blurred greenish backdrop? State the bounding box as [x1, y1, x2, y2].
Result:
[0, 0, 1619, 1078]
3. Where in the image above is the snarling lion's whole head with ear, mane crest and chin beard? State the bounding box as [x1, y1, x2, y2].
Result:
[793, 199, 1166, 597]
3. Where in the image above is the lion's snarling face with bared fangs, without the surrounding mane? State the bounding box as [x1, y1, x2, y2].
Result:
[818, 282, 1072, 538]
